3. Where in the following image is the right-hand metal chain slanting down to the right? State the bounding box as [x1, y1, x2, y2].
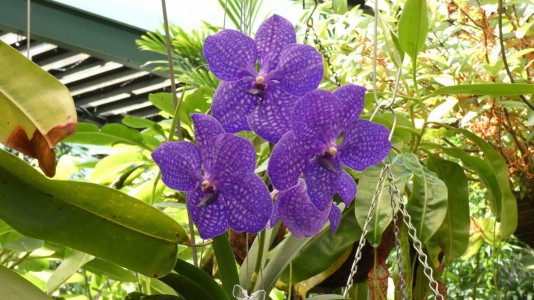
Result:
[390, 179, 444, 300]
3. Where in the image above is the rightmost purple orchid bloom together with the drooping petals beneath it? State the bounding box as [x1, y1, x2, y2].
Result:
[267, 85, 391, 236]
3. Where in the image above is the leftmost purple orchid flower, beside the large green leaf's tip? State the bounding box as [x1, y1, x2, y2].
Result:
[152, 114, 273, 239]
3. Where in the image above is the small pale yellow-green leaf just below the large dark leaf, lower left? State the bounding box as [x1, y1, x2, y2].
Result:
[46, 250, 94, 294]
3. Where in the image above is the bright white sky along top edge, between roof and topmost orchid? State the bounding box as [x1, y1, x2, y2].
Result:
[54, 0, 302, 30]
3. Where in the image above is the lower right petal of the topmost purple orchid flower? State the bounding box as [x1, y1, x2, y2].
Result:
[248, 82, 299, 143]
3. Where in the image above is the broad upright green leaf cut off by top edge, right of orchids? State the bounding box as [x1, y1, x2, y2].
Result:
[398, 0, 428, 60]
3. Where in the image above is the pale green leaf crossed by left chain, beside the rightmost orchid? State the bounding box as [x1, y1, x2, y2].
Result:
[354, 157, 410, 247]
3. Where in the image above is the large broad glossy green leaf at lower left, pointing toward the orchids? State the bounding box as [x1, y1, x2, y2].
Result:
[0, 151, 188, 277]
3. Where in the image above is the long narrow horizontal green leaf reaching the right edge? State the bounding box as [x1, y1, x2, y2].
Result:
[430, 83, 534, 97]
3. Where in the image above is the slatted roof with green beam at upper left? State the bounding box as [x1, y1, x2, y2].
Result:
[0, 0, 174, 124]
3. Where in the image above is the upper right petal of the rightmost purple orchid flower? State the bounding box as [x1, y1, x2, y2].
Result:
[334, 84, 366, 128]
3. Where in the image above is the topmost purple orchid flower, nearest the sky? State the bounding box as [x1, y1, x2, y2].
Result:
[203, 15, 324, 143]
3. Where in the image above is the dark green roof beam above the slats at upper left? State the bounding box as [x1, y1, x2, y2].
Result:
[0, 0, 162, 75]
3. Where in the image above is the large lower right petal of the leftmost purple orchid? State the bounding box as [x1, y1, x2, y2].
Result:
[217, 173, 273, 233]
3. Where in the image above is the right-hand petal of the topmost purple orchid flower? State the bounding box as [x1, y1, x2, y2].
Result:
[270, 44, 324, 96]
